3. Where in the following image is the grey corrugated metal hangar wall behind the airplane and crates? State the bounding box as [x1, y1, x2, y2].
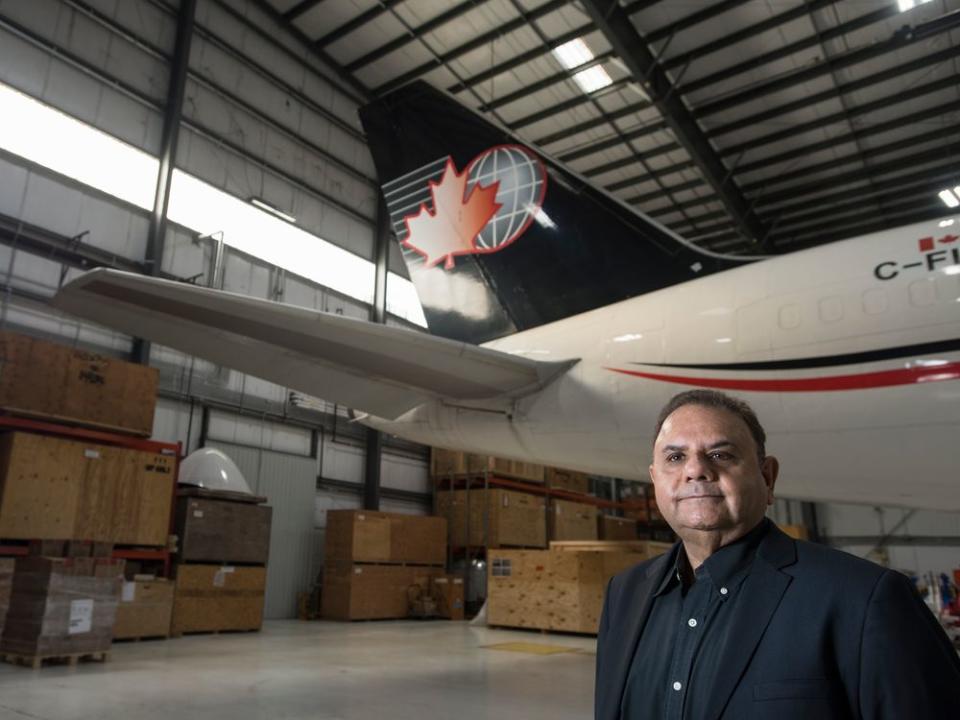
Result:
[0, 0, 960, 617]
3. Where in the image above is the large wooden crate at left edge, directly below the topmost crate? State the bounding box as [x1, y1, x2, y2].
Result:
[0, 432, 175, 546]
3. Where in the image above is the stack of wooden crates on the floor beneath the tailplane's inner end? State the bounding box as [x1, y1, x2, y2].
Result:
[321, 510, 446, 620]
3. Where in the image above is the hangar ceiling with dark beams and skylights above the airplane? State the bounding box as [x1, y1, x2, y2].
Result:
[260, 0, 960, 253]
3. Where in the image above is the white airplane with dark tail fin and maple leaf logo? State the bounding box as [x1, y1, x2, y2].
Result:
[55, 82, 960, 511]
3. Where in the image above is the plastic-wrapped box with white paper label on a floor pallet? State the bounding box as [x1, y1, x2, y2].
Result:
[0, 556, 123, 658]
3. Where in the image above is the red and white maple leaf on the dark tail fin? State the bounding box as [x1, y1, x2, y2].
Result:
[400, 158, 500, 270]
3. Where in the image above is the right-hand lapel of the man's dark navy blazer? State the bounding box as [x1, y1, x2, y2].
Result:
[707, 526, 796, 718]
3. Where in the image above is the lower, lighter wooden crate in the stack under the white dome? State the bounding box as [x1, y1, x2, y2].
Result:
[170, 565, 267, 637]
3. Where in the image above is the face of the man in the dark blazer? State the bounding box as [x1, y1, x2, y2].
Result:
[650, 405, 777, 540]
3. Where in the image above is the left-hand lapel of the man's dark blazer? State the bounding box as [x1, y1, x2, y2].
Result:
[597, 543, 680, 720]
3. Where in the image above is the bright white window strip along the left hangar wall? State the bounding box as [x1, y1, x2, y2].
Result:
[0, 83, 427, 327]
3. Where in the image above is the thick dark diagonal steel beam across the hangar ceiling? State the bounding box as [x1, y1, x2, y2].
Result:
[582, 0, 766, 241]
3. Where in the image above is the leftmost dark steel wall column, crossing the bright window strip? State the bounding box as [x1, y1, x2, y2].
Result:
[133, 0, 197, 365]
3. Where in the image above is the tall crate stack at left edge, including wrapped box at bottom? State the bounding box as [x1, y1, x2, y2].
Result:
[0, 332, 178, 664]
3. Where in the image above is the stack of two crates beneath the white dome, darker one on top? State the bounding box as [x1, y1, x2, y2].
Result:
[170, 486, 272, 637]
